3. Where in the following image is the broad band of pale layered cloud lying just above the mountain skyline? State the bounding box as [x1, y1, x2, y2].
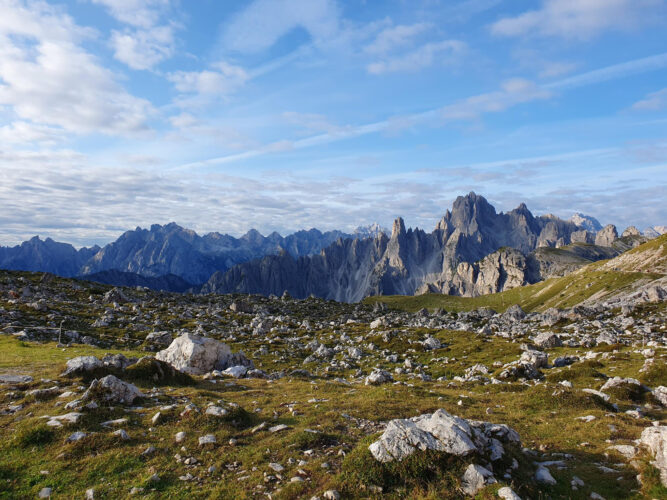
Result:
[0, 144, 667, 244]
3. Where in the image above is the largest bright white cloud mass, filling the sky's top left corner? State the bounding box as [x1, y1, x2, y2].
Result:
[0, 0, 153, 134]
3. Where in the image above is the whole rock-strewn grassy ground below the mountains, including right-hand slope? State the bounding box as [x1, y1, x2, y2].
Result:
[0, 236, 667, 499]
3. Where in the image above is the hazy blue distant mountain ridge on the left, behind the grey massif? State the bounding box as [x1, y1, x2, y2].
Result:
[0, 223, 366, 291]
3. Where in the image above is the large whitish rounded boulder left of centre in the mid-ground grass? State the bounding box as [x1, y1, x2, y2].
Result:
[155, 333, 254, 375]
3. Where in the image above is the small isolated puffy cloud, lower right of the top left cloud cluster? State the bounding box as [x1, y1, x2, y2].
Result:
[168, 62, 248, 96]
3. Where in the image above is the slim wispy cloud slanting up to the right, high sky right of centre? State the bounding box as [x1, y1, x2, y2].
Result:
[366, 40, 467, 75]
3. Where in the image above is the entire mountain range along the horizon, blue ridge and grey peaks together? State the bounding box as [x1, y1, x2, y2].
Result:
[0, 193, 667, 302]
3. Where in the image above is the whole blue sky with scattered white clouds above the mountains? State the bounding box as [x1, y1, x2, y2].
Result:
[0, 0, 667, 246]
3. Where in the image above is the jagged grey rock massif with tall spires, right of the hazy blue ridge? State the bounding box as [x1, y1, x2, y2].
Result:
[202, 193, 648, 302]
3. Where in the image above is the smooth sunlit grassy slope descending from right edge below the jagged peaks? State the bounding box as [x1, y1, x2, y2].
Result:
[366, 235, 667, 312]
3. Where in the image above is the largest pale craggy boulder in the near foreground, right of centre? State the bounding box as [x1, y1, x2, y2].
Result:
[368, 409, 520, 462]
